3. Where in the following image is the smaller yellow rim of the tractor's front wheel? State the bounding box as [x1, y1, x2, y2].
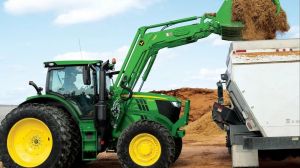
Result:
[129, 133, 161, 166]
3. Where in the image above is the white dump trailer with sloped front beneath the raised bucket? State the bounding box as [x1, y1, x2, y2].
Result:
[213, 39, 300, 167]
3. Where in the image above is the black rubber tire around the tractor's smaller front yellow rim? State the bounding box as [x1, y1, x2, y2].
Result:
[117, 120, 175, 168]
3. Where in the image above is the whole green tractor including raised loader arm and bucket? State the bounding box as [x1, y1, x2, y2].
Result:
[0, 0, 282, 168]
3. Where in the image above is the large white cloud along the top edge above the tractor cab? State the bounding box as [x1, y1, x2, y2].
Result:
[4, 0, 161, 25]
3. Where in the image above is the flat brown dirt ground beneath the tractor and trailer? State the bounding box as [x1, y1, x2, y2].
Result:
[78, 136, 300, 168]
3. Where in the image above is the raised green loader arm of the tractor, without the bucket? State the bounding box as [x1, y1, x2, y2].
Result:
[114, 15, 221, 94]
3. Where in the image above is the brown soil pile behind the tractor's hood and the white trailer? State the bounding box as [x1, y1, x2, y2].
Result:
[154, 88, 228, 144]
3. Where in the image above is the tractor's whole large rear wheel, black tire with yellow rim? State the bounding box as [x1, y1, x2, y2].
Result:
[0, 104, 78, 168]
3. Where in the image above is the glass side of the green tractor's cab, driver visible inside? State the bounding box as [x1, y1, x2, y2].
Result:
[47, 66, 95, 116]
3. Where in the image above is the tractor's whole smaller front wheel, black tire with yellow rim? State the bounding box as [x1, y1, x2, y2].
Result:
[117, 120, 175, 168]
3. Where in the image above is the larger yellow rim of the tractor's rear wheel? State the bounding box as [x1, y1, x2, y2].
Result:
[7, 118, 53, 167]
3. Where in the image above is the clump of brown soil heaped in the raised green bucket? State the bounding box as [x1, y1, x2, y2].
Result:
[232, 0, 290, 40]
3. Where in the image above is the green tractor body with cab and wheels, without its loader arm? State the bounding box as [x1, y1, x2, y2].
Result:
[1, 60, 189, 167]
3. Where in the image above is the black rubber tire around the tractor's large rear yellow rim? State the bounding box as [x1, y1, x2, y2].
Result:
[0, 104, 79, 168]
